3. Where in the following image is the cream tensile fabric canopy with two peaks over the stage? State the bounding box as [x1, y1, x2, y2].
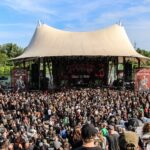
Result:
[14, 24, 148, 59]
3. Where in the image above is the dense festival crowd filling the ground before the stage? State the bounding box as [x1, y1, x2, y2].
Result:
[0, 88, 150, 150]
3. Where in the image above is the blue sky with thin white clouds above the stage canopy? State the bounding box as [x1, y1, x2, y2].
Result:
[0, 0, 150, 51]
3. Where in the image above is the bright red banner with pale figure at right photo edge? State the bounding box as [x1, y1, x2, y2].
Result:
[135, 68, 150, 91]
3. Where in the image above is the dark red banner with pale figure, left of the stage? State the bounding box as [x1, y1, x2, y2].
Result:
[12, 68, 28, 91]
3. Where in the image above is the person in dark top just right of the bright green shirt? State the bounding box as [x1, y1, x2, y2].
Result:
[106, 125, 120, 150]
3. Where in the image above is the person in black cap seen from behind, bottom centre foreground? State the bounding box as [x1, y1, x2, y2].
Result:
[73, 124, 101, 150]
